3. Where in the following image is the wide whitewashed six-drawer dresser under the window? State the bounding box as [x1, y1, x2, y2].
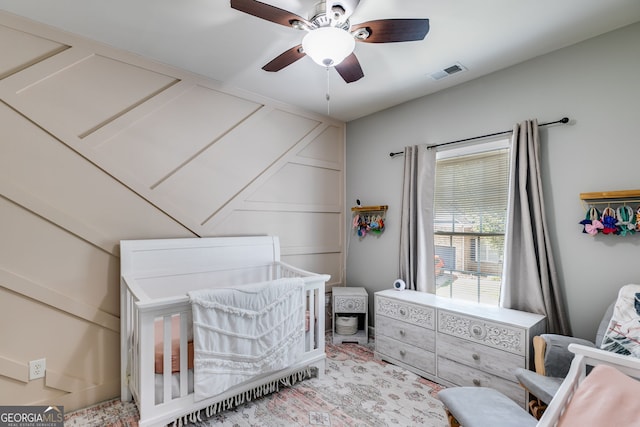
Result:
[374, 289, 545, 407]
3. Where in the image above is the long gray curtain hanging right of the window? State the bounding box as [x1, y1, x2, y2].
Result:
[500, 120, 571, 335]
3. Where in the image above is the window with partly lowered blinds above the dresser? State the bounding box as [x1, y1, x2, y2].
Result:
[433, 140, 509, 305]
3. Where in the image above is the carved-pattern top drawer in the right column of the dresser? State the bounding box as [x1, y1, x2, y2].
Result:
[438, 310, 527, 356]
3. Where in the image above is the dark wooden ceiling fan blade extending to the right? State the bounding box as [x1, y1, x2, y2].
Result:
[351, 19, 429, 43]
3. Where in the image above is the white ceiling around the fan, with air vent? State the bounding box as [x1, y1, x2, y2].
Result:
[0, 0, 640, 121]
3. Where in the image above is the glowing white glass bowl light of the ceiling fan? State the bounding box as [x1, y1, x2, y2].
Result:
[302, 27, 356, 67]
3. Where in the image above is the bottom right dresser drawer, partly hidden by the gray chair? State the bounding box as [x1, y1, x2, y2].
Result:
[438, 355, 526, 407]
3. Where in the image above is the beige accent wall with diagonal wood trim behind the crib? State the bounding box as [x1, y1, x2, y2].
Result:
[0, 12, 345, 410]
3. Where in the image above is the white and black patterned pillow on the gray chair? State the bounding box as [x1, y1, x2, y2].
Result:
[600, 285, 640, 357]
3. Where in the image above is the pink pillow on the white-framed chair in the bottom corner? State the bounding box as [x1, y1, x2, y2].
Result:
[558, 365, 640, 427]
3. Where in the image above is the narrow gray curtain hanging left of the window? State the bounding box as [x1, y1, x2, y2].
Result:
[398, 145, 436, 293]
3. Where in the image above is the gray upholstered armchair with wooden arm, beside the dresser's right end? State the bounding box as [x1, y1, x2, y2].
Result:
[516, 303, 615, 419]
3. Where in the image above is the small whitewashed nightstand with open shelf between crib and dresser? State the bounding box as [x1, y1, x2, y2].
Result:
[331, 287, 369, 344]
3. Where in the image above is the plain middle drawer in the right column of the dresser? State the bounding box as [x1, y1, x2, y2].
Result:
[437, 334, 526, 381]
